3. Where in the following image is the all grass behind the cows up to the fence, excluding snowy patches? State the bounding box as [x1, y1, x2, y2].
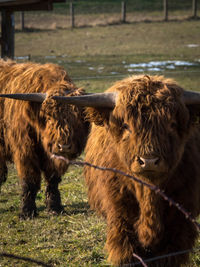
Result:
[15, 20, 200, 91]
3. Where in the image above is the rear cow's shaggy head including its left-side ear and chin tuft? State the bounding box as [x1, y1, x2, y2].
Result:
[27, 93, 88, 174]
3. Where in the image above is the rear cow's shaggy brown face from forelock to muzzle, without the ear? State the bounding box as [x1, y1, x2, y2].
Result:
[40, 100, 86, 160]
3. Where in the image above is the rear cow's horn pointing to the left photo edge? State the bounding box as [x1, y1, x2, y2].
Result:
[0, 93, 46, 103]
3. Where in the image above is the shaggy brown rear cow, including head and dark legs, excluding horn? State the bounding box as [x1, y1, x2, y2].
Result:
[0, 60, 88, 218]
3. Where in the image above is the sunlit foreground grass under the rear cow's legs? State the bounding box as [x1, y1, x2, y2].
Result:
[0, 166, 108, 267]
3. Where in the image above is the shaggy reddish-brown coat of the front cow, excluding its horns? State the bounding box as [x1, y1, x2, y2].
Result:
[84, 76, 200, 267]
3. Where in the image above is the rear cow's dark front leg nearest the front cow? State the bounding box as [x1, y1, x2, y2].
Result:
[45, 172, 63, 214]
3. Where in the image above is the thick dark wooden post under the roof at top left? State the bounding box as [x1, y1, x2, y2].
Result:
[1, 10, 15, 59]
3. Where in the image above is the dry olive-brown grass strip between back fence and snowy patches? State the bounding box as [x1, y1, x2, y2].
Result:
[15, 20, 200, 59]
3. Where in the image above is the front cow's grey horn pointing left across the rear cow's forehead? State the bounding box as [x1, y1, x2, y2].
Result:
[52, 93, 117, 108]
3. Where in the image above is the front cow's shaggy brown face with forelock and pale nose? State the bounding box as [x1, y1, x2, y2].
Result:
[87, 77, 197, 183]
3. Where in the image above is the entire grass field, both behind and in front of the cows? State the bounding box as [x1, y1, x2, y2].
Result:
[0, 8, 200, 267]
